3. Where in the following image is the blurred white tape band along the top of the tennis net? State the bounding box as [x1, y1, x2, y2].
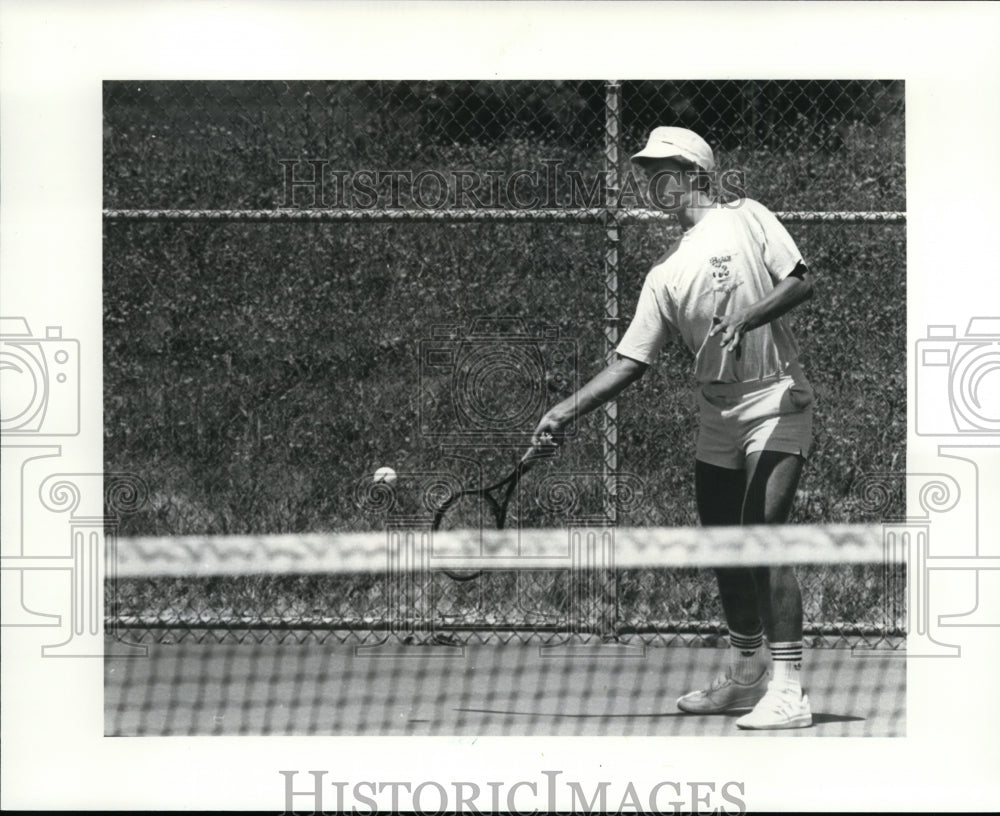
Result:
[107, 525, 887, 578]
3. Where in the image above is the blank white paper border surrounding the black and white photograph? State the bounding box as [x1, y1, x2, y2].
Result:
[0, 0, 1000, 810]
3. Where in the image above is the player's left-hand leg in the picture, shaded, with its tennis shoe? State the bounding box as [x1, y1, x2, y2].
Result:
[677, 461, 768, 714]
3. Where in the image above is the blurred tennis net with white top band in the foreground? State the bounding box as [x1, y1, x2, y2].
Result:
[105, 526, 905, 736]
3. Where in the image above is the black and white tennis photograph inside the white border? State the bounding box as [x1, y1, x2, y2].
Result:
[104, 80, 906, 737]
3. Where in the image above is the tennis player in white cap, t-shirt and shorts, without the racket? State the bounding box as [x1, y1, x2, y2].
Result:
[533, 127, 813, 729]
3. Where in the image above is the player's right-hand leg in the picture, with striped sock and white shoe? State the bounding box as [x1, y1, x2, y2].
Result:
[736, 451, 812, 728]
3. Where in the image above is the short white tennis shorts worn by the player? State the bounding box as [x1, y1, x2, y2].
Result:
[696, 377, 813, 470]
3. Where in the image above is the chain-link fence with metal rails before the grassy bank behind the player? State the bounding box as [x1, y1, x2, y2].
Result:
[104, 81, 906, 640]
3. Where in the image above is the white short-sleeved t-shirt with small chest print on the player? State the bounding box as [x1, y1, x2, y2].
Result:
[617, 198, 802, 383]
